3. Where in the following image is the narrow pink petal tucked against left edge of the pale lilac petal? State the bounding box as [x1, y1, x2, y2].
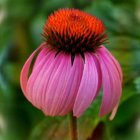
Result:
[60, 55, 84, 116]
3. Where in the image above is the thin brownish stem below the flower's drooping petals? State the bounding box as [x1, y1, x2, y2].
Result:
[69, 112, 78, 140]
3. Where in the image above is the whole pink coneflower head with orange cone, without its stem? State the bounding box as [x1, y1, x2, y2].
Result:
[20, 9, 122, 119]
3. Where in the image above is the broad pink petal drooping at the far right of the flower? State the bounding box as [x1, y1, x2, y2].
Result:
[97, 47, 122, 116]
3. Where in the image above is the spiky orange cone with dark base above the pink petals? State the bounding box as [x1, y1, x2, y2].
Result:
[43, 9, 107, 54]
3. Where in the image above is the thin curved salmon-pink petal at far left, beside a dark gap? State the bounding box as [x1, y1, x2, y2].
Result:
[20, 43, 45, 95]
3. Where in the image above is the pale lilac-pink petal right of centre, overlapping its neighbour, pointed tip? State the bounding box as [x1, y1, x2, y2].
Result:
[73, 53, 100, 117]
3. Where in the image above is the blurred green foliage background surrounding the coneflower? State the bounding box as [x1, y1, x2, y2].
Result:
[0, 0, 140, 140]
